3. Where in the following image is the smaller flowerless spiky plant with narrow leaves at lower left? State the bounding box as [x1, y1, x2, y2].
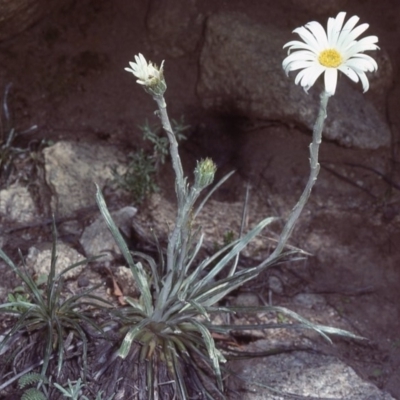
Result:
[0, 224, 111, 382]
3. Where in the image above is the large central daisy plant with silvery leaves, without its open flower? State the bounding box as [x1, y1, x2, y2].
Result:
[93, 54, 357, 399]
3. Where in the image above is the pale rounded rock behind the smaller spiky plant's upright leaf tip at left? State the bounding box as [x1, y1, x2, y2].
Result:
[26, 243, 86, 279]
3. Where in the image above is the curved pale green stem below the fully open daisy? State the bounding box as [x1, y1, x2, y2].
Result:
[263, 91, 329, 264]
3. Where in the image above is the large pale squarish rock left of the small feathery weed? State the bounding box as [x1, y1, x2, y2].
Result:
[43, 141, 124, 217]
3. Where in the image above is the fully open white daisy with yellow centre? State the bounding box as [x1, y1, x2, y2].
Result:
[282, 12, 379, 96]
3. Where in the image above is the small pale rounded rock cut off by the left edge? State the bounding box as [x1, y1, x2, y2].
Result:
[0, 183, 37, 223]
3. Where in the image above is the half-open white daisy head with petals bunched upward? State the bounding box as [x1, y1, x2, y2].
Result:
[125, 53, 167, 95]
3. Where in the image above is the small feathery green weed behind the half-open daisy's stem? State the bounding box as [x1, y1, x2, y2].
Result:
[113, 117, 189, 204]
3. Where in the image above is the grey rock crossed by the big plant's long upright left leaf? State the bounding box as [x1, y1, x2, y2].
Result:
[79, 207, 137, 261]
